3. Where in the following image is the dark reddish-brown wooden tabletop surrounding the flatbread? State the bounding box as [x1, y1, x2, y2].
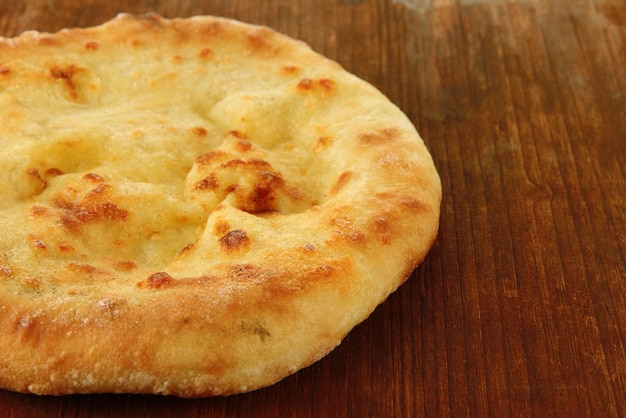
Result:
[0, 0, 626, 418]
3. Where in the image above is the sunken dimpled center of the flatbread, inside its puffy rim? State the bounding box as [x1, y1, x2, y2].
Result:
[0, 26, 340, 283]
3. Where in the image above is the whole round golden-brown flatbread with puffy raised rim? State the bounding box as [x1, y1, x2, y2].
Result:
[0, 15, 441, 397]
